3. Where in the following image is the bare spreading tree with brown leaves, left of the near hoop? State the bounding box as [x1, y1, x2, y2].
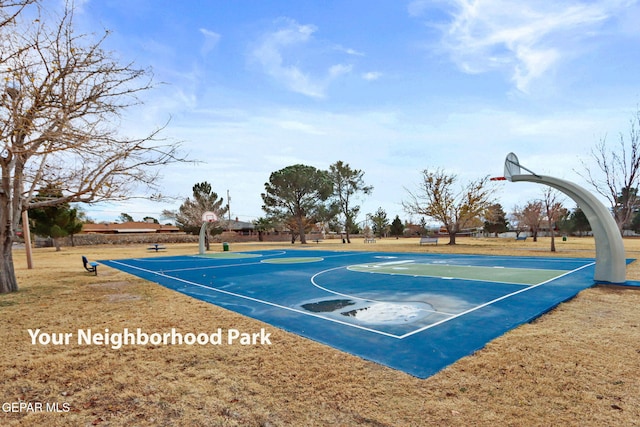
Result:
[403, 169, 493, 245]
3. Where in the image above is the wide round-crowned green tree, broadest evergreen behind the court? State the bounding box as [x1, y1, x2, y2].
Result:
[261, 164, 333, 244]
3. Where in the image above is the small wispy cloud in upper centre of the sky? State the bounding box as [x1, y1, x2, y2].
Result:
[251, 19, 356, 98]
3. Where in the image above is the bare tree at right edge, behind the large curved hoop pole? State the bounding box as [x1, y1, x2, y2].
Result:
[578, 108, 640, 233]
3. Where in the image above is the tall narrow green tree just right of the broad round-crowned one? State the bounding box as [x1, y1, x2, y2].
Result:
[329, 161, 373, 243]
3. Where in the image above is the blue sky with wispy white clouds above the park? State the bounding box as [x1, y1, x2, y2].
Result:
[63, 0, 640, 226]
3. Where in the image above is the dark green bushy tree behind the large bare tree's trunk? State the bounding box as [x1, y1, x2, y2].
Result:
[29, 187, 82, 251]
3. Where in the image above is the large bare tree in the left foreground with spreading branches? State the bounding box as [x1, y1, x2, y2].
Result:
[0, 4, 188, 293]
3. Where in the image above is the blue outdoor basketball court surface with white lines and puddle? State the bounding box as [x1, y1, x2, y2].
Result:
[100, 249, 595, 378]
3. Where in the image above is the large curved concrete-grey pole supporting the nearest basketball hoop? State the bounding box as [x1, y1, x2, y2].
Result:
[510, 175, 627, 283]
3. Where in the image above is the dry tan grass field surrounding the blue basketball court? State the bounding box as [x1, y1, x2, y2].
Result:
[0, 238, 640, 426]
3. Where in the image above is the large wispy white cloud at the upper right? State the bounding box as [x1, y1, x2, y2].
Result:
[418, 0, 629, 92]
